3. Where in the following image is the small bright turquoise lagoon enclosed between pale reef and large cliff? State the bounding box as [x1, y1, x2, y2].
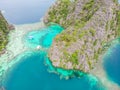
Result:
[25, 25, 63, 48]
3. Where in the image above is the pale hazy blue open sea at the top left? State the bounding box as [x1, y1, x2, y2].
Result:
[0, 0, 55, 24]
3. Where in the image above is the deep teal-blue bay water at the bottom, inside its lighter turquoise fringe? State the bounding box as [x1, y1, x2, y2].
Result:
[5, 52, 104, 90]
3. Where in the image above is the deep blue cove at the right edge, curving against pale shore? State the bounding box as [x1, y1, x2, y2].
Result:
[103, 38, 120, 86]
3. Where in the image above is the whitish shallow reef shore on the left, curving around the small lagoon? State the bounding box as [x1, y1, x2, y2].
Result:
[0, 22, 45, 83]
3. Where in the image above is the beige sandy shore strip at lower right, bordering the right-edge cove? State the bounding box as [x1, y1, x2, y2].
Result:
[90, 46, 120, 90]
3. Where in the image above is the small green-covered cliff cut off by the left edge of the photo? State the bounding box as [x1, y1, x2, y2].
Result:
[0, 12, 14, 54]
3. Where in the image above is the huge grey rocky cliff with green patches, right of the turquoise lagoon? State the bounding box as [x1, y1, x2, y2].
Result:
[44, 0, 120, 72]
